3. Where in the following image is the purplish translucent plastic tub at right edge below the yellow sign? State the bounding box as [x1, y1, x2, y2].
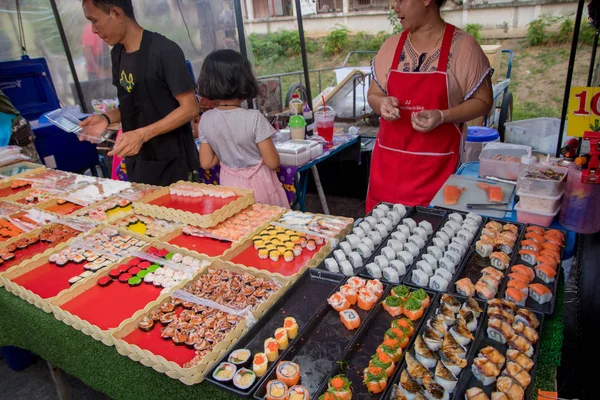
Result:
[560, 164, 600, 234]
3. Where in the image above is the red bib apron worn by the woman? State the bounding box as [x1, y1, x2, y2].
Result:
[366, 24, 462, 212]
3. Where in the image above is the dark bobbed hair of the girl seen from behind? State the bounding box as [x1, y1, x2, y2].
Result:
[198, 50, 258, 100]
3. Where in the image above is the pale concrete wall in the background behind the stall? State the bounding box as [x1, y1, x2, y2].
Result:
[245, 0, 577, 38]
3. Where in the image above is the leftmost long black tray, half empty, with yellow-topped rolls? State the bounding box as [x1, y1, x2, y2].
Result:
[206, 268, 344, 397]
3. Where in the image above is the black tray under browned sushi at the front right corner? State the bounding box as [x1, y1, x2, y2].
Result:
[453, 311, 544, 399]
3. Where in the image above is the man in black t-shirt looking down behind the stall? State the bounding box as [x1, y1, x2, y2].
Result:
[81, 0, 200, 186]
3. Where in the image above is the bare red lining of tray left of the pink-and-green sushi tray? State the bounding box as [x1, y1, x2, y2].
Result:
[13, 263, 85, 299]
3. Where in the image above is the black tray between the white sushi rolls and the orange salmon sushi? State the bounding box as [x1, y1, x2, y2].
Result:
[448, 218, 525, 297]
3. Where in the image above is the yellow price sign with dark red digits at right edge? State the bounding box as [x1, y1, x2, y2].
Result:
[567, 86, 600, 137]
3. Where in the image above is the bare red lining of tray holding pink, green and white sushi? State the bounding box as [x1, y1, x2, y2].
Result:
[60, 279, 162, 330]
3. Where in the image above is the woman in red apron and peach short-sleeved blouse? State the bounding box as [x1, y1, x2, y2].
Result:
[366, 0, 493, 211]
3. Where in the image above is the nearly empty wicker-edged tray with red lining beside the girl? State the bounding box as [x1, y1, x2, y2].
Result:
[133, 182, 254, 228]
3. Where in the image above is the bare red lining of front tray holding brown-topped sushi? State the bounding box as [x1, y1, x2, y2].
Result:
[122, 308, 196, 367]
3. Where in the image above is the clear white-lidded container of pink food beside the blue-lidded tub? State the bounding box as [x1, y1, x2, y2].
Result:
[479, 142, 531, 181]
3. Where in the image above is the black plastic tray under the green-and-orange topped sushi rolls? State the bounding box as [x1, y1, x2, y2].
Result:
[318, 287, 437, 400]
